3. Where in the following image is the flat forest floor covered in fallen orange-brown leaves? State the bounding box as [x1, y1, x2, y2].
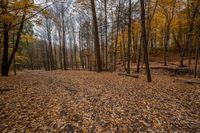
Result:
[0, 70, 200, 133]
